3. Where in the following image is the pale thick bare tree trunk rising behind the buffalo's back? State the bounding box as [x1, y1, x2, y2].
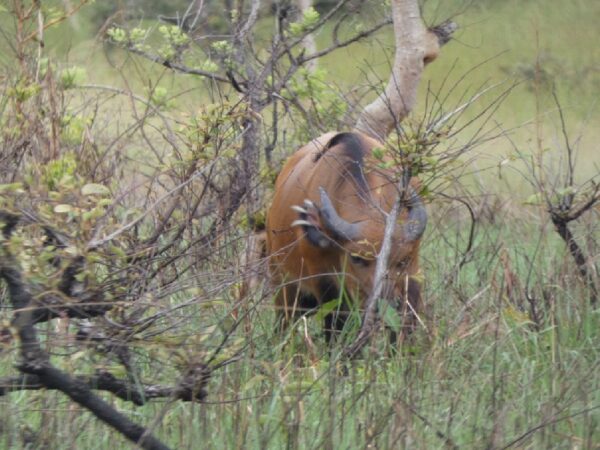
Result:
[356, 0, 440, 140]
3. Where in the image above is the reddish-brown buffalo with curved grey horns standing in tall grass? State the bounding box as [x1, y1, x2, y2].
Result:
[266, 133, 427, 340]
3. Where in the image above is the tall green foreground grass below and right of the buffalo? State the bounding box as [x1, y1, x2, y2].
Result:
[0, 216, 600, 449]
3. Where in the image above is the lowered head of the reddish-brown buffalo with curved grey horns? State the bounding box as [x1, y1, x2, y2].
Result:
[291, 185, 427, 299]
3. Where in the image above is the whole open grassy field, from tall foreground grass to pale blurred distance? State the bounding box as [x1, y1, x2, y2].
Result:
[0, 0, 600, 450]
